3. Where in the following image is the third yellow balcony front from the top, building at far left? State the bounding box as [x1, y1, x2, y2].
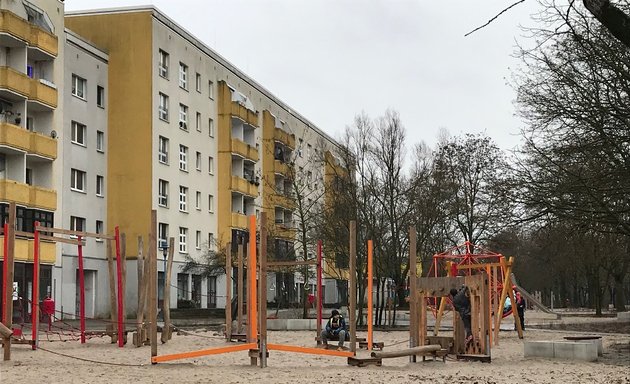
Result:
[0, 123, 57, 160]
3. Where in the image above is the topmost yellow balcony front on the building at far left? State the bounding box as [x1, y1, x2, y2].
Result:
[0, 10, 59, 60]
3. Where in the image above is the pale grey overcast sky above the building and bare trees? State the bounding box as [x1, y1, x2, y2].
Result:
[65, 0, 537, 154]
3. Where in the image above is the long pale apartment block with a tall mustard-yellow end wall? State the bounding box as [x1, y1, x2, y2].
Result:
[65, 6, 348, 308]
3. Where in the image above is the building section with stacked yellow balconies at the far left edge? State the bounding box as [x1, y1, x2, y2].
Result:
[0, 0, 64, 322]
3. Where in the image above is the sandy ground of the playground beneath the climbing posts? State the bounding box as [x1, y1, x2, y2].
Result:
[0, 312, 630, 384]
